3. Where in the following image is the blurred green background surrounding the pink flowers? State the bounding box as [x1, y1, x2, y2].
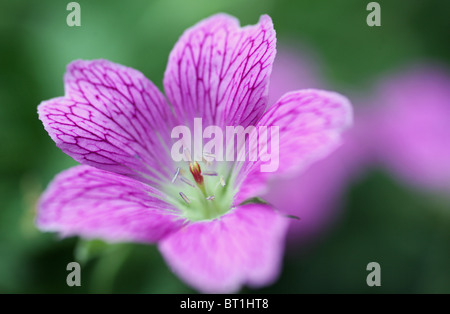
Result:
[0, 0, 450, 293]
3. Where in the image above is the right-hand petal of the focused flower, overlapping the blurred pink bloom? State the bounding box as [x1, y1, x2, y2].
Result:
[237, 89, 352, 202]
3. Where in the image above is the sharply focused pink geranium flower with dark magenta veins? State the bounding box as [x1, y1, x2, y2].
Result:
[37, 14, 351, 292]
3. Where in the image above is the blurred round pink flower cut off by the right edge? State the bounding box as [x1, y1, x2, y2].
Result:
[371, 66, 450, 191]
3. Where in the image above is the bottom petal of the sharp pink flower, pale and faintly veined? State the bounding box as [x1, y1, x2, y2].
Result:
[159, 204, 288, 293]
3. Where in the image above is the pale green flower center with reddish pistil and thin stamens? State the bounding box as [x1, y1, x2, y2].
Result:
[165, 154, 234, 221]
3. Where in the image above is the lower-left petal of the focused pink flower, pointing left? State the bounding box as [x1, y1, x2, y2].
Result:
[37, 166, 182, 242]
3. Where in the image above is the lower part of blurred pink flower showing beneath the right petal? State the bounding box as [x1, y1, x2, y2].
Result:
[263, 126, 369, 246]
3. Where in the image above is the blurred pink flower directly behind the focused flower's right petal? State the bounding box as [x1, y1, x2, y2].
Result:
[262, 45, 370, 246]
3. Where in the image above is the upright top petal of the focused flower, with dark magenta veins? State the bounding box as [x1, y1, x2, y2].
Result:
[164, 14, 276, 127]
